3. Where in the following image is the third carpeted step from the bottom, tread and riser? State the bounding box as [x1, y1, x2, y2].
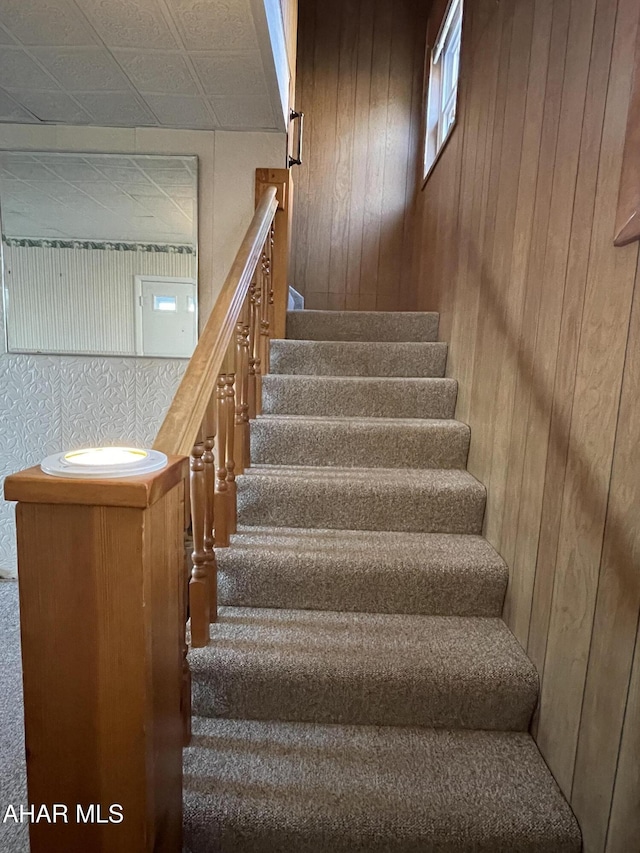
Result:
[216, 527, 508, 616]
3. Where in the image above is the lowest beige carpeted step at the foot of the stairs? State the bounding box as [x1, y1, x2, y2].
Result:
[184, 717, 581, 853]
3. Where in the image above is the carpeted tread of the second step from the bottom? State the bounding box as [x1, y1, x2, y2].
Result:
[190, 607, 538, 693]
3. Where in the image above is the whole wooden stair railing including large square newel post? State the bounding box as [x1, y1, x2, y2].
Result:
[4, 169, 291, 853]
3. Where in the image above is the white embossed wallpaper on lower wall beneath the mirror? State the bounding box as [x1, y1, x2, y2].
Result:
[0, 350, 187, 577]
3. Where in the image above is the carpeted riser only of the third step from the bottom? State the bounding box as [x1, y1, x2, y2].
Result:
[217, 547, 507, 617]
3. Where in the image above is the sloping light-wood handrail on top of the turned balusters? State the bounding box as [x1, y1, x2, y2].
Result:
[153, 187, 278, 456]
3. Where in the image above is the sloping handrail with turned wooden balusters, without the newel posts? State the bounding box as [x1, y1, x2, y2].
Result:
[153, 187, 278, 647]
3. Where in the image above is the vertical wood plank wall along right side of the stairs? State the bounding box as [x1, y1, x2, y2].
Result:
[410, 0, 640, 853]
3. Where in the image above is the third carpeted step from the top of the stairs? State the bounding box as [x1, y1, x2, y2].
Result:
[262, 374, 458, 418]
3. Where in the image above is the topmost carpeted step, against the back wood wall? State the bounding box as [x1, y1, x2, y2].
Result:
[287, 311, 439, 341]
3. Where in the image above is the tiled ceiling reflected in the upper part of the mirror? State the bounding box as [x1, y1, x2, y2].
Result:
[0, 152, 198, 245]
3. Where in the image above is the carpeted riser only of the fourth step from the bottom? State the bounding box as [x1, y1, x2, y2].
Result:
[236, 474, 485, 533]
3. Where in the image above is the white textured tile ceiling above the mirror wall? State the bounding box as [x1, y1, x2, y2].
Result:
[0, 0, 283, 130]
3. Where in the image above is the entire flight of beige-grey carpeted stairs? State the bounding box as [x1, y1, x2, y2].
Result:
[184, 311, 581, 853]
